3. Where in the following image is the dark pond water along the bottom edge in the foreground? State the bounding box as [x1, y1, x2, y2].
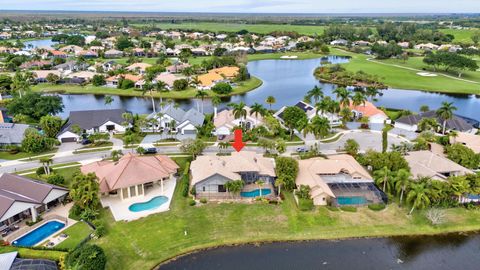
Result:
[158, 234, 480, 270]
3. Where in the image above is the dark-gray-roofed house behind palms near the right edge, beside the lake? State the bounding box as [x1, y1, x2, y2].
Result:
[395, 110, 475, 133]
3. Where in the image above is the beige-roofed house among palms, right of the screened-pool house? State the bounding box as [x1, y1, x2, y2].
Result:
[405, 151, 473, 181]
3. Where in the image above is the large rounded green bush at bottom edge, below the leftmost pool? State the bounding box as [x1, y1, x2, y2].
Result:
[65, 244, 107, 270]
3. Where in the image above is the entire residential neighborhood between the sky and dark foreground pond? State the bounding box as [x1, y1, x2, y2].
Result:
[0, 10, 480, 269]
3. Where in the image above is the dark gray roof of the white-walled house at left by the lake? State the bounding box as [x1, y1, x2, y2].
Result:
[62, 109, 127, 132]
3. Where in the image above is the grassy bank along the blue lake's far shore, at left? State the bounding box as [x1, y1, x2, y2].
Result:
[32, 77, 262, 99]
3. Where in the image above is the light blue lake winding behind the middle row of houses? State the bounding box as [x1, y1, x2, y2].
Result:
[57, 56, 480, 120]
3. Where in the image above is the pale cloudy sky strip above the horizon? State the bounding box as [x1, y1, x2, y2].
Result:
[0, 0, 480, 13]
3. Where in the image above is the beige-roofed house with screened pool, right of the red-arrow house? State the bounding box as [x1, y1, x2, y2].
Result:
[296, 155, 383, 205]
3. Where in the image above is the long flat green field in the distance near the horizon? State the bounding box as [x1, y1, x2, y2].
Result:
[132, 22, 325, 35]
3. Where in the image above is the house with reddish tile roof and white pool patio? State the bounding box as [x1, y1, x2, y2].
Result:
[80, 153, 179, 220]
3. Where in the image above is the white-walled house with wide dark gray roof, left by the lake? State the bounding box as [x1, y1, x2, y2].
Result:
[57, 109, 127, 142]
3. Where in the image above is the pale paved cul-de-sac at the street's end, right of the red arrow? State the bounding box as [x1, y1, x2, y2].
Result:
[320, 130, 408, 154]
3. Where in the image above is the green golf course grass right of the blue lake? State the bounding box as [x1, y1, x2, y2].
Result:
[332, 49, 480, 94]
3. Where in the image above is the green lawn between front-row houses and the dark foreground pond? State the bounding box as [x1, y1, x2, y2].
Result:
[90, 159, 480, 269]
